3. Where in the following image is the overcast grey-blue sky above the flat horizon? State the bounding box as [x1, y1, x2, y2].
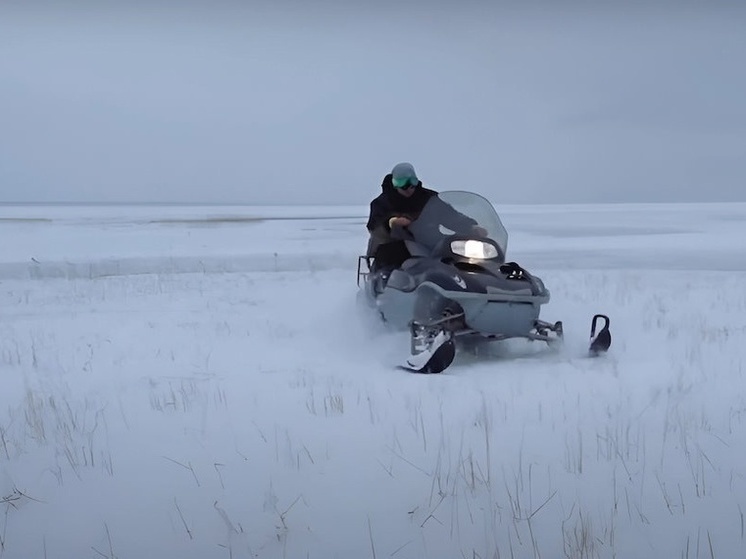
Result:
[0, 0, 746, 204]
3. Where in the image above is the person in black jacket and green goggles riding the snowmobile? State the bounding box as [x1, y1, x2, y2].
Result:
[366, 162, 486, 269]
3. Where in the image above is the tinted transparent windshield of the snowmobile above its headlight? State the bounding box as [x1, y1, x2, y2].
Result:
[409, 190, 508, 254]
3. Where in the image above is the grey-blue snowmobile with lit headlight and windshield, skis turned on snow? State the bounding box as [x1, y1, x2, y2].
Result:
[357, 191, 611, 373]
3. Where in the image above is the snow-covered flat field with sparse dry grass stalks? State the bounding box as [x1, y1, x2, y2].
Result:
[0, 204, 746, 559]
